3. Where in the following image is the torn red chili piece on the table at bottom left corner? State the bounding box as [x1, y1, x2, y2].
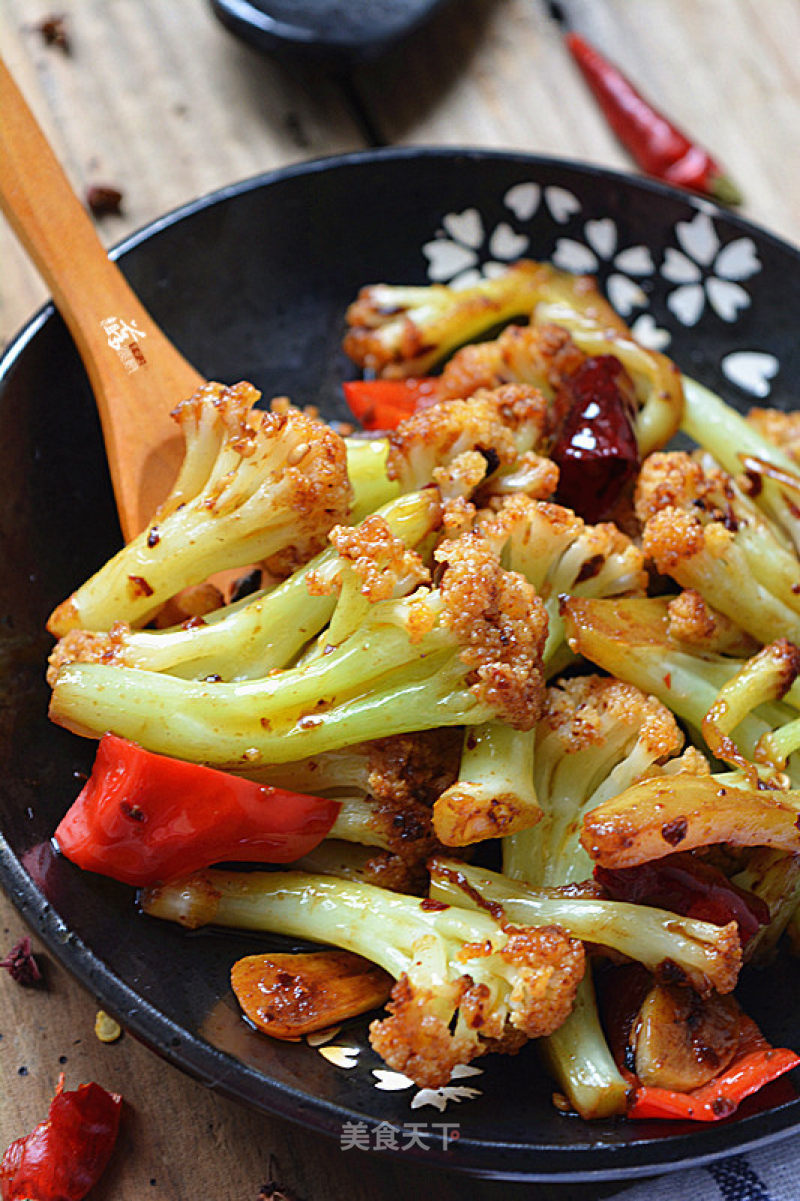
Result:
[0, 1075, 123, 1201]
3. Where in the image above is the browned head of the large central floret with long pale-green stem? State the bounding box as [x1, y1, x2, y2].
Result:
[435, 533, 548, 730]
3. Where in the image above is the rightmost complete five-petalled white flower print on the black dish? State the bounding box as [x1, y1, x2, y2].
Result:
[661, 213, 762, 325]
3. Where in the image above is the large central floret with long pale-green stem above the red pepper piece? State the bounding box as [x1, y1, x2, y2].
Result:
[50, 533, 547, 770]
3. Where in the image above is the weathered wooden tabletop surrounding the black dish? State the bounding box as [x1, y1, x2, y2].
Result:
[0, 0, 800, 1201]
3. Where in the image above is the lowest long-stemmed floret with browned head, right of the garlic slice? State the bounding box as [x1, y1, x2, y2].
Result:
[142, 870, 585, 1088]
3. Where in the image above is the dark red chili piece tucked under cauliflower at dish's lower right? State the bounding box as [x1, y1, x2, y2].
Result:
[595, 854, 770, 945]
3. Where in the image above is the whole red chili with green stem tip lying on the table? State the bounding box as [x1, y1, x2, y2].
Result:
[566, 32, 742, 204]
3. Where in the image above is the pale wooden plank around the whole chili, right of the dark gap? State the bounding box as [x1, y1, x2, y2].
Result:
[357, 0, 800, 243]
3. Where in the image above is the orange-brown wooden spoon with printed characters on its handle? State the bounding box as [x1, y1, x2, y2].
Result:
[0, 60, 203, 538]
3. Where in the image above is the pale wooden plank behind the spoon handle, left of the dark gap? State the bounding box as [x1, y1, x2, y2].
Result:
[0, 0, 364, 346]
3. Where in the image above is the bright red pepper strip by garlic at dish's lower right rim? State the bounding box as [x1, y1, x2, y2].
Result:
[628, 1014, 800, 1122]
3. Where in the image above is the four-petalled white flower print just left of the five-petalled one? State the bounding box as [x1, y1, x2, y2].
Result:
[553, 217, 656, 317]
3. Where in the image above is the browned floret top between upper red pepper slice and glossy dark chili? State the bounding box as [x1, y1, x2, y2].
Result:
[437, 323, 586, 405]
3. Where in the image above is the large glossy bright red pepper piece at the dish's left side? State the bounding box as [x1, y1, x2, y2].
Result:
[55, 734, 339, 888]
